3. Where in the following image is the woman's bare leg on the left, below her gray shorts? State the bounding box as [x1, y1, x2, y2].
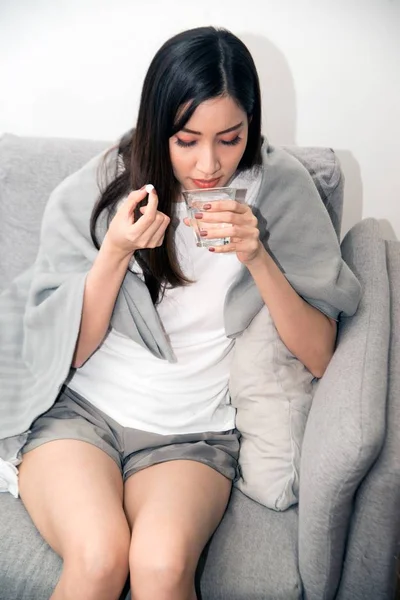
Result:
[19, 440, 130, 600]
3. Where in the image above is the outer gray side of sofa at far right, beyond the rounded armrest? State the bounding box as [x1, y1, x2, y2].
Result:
[337, 241, 400, 600]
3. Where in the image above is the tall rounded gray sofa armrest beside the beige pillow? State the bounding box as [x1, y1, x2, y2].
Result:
[299, 219, 390, 600]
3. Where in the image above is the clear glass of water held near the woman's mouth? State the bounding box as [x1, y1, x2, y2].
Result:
[182, 187, 246, 248]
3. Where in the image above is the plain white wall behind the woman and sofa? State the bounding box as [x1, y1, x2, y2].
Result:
[0, 0, 400, 238]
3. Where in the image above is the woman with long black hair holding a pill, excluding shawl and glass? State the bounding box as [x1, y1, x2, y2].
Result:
[16, 27, 360, 600]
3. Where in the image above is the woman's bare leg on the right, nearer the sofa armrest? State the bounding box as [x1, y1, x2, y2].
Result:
[124, 460, 231, 600]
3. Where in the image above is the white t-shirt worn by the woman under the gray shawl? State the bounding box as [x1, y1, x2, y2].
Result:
[69, 203, 242, 435]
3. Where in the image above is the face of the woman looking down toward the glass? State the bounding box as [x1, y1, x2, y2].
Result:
[169, 96, 248, 190]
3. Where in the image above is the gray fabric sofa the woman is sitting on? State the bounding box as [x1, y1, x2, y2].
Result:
[0, 135, 400, 600]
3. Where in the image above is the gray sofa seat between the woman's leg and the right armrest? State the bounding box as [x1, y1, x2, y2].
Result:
[199, 489, 302, 600]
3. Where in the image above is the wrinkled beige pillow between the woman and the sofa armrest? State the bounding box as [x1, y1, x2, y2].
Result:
[229, 306, 313, 510]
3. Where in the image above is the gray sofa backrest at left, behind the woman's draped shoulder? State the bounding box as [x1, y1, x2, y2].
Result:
[0, 134, 110, 290]
